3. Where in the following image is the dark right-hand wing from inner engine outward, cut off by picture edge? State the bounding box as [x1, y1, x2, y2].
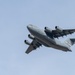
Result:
[52, 29, 75, 38]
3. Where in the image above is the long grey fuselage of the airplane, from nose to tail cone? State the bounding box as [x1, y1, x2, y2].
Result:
[27, 25, 70, 51]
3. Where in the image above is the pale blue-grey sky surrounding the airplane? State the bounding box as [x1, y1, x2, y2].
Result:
[0, 0, 75, 75]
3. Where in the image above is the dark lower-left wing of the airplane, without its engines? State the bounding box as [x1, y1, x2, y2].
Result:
[25, 39, 42, 54]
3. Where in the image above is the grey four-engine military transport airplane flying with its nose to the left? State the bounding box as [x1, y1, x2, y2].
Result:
[24, 24, 75, 54]
